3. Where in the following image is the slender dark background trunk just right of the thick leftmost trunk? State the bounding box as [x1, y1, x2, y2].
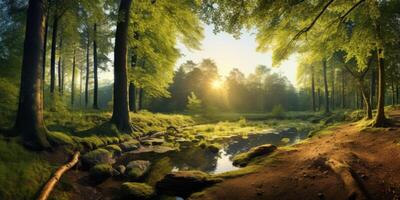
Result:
[50, 14, 58, 94]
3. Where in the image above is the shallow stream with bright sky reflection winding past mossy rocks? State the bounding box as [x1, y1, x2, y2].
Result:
[111, 128, 308, 200]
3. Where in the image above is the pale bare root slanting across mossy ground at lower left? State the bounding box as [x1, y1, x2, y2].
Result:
[37, 151, 80, 200]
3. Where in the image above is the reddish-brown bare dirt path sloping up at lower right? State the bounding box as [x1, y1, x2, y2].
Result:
[191, 111, 400, 200]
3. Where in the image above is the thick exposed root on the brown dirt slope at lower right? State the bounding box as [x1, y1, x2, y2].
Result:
[326, 158, 369, 200]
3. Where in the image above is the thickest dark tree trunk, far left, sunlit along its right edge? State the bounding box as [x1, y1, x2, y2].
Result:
[15, 0, 50, 149]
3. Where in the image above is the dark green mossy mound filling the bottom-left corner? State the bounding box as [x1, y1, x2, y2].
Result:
[0, 139, 54, 199]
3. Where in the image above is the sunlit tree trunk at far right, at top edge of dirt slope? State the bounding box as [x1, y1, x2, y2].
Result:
[372, 45, 386, 127]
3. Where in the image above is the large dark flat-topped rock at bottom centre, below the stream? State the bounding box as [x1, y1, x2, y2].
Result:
[156, 171, 222, 197]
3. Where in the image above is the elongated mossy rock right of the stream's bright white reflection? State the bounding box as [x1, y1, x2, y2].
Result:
[233, 144, 277, 167]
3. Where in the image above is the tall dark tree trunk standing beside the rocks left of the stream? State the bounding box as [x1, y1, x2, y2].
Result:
[111, 0, 132, 133]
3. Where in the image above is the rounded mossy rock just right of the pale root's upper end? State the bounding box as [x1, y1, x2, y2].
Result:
[82, 148, 115, 168]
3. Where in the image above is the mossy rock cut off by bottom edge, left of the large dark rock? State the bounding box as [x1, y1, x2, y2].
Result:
[121, 182, 155, 200]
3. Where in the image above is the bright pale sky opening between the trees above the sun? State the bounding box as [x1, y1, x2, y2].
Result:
[177, 26, 297, 86]
